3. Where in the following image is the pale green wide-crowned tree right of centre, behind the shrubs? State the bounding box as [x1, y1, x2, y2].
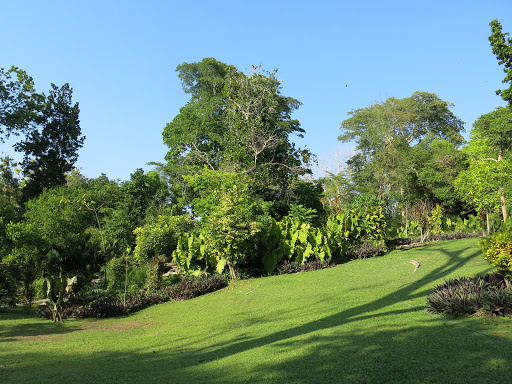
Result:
[338, 92, 463, 204]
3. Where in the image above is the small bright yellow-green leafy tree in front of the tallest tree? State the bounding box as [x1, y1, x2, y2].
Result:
[173, 169, 269, 278]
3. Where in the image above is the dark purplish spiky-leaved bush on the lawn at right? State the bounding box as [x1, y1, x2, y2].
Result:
[427, 273, 512, 316]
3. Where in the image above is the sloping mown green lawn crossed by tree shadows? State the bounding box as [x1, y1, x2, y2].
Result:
[0, 239, 512, 384]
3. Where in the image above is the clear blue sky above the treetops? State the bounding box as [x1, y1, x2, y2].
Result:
[0, 0, 512, 180]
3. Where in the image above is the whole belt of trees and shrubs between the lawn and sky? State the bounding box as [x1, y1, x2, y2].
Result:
[0, 21, 512, 320]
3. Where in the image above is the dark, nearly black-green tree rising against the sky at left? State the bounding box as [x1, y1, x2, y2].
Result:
[15, 84, 85, 201]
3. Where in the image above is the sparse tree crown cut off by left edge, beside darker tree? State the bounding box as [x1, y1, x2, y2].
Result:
[0, 66, 44, 142]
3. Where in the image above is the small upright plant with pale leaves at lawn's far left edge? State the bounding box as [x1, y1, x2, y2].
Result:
[46, 275, 77, 321]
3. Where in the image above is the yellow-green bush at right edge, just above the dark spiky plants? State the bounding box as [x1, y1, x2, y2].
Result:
[480, 229, 512, 281]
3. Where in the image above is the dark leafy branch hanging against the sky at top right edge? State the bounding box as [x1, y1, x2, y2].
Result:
[489, 20, 512, 105]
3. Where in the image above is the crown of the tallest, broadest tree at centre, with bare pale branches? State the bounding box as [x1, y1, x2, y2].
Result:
[163, 58, 311, 218]
